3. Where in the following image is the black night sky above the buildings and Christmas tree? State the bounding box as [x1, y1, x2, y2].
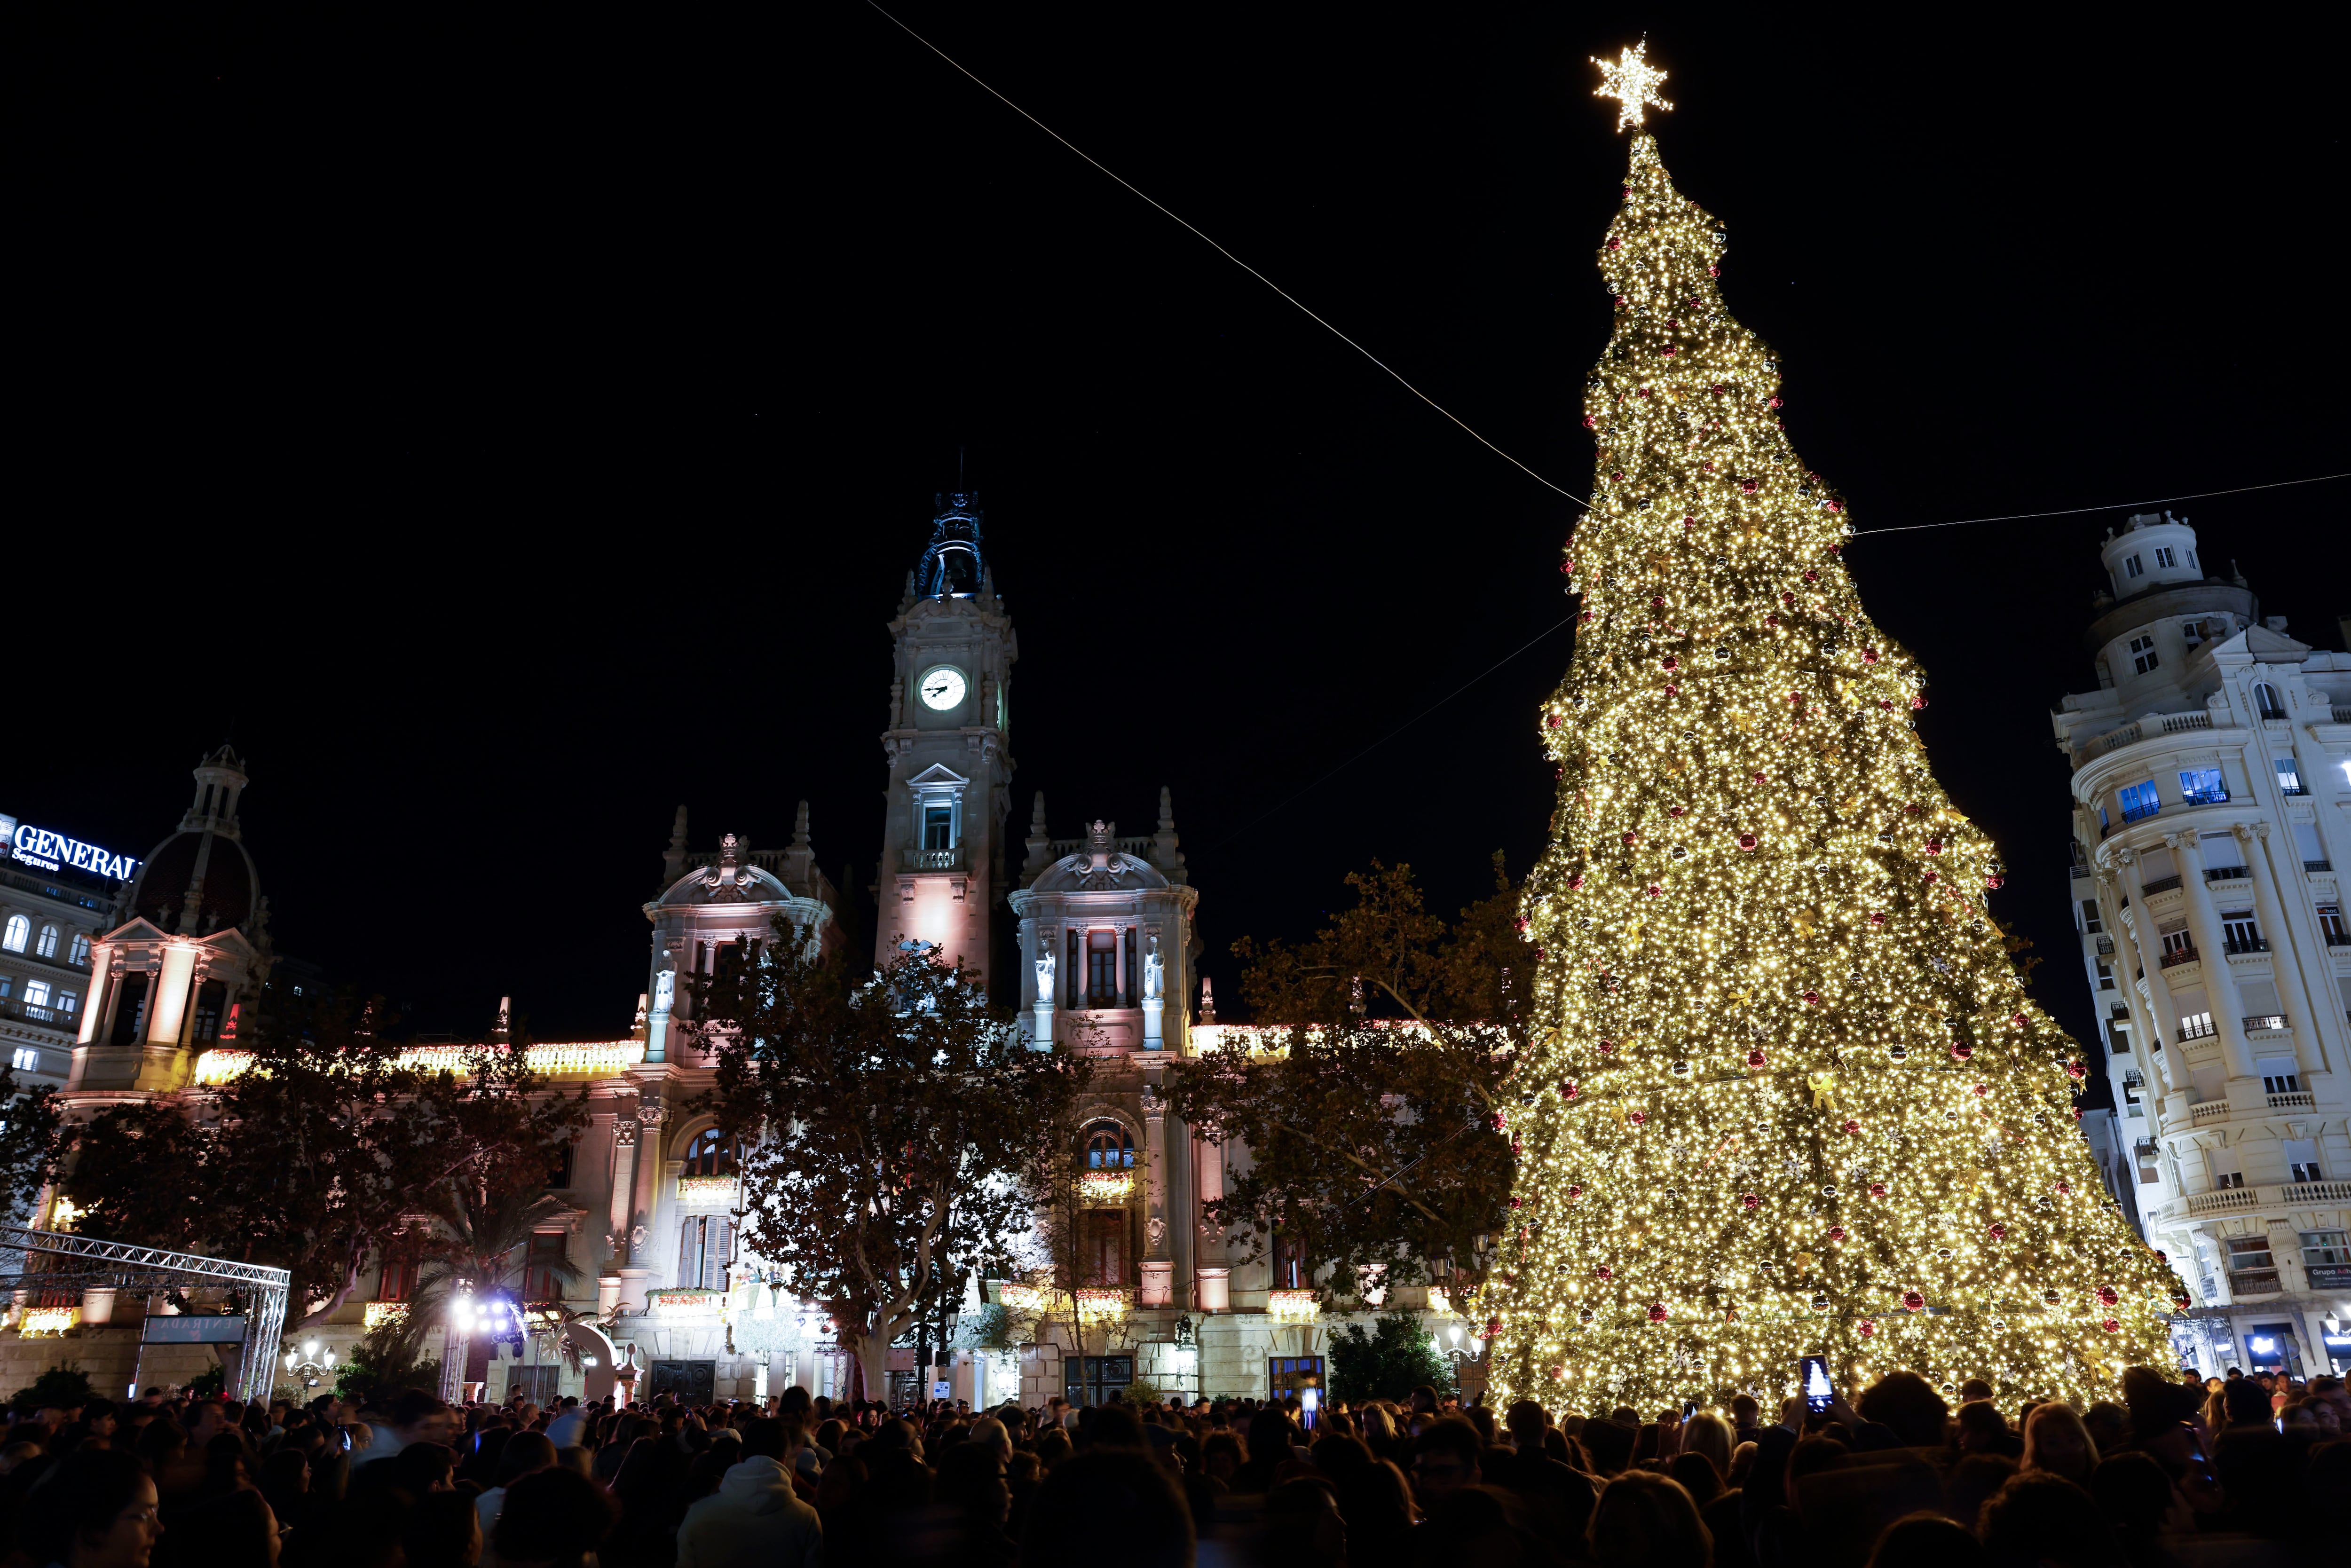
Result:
[0, 15, 2351, 1037]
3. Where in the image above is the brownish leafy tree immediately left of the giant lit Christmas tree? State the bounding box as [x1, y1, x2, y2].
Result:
[1168, 856, 1523, 1295]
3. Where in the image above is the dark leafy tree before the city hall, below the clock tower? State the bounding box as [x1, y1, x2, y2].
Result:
[703, 922, 1086, 1394]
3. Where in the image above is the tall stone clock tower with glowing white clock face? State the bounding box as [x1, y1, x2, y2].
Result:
[875, 491, 1020, 983]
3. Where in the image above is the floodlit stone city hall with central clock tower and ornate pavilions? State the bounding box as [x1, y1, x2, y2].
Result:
[27, 494, 1439, 1406]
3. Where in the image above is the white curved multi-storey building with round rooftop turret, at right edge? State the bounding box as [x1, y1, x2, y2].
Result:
[2052, 512, 2351, 1375]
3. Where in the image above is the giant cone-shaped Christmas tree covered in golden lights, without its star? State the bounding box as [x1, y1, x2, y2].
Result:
[1486, 134, 2179, 1410]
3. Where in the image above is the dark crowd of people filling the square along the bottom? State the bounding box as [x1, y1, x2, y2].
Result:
[0, 1368, 2351, 1568]
